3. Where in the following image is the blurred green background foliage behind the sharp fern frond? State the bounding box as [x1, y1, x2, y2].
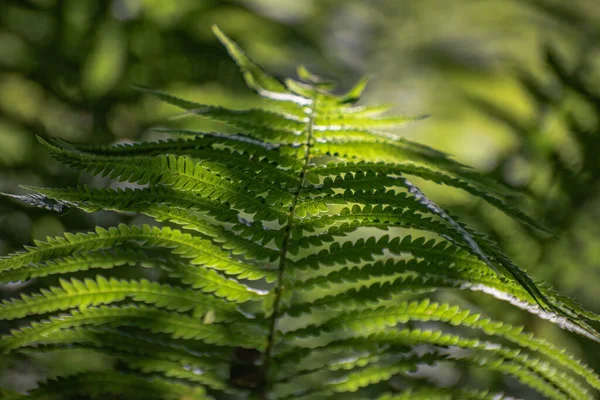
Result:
[0, 0, 600, 398]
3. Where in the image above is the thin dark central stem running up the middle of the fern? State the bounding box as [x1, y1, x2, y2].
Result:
[258, 98, 317, 399]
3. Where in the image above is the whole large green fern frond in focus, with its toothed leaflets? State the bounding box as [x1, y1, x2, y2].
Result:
[0, 28, 600, 400]
